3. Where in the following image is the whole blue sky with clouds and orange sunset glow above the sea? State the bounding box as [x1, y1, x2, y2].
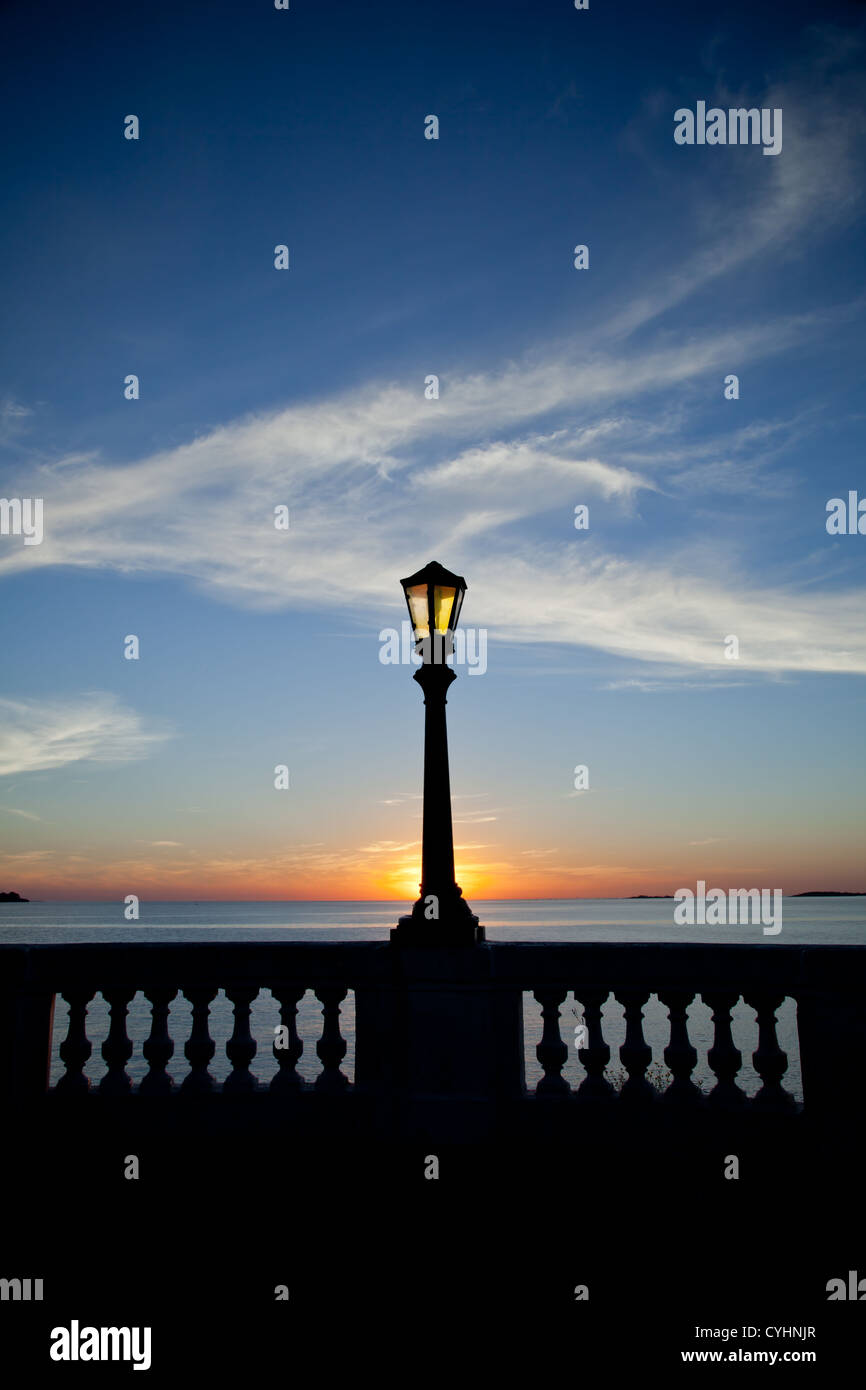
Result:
[0, 0, 866, 902]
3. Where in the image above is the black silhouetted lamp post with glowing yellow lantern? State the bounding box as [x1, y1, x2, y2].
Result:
[391, 560, 484, 947]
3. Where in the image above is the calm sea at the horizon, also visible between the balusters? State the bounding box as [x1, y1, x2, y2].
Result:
[0, 898, 866, 1099]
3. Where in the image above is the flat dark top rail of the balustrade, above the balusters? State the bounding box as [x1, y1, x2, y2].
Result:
[0, 941, 866, 997]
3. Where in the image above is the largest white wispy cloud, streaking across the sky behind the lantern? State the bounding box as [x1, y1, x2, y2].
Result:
[0, 315, 866, 671]
